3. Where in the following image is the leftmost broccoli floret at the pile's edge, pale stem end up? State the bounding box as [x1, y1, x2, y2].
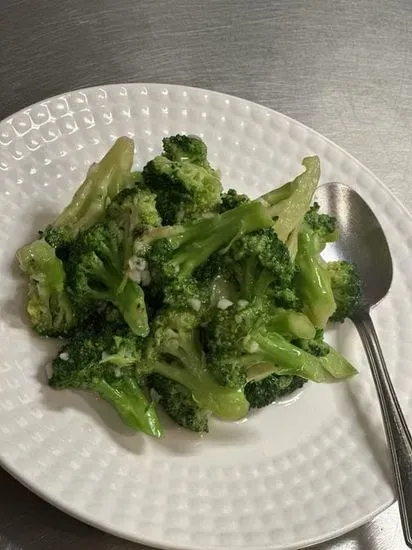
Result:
[17, 240, 78, 336]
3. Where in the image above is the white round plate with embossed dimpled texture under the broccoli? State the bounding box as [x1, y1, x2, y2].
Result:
[0, 84, 412, 550]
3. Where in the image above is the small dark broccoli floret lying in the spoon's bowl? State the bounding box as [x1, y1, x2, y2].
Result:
[326, 261, 363, 322]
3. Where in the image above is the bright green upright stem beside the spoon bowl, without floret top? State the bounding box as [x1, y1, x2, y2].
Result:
[295, 227, 336, 329]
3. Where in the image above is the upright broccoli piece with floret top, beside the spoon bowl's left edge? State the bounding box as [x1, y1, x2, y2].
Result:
[295, 204, 337, 329]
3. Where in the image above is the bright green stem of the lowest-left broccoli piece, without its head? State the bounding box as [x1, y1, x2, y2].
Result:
[92, 377, 163, 437]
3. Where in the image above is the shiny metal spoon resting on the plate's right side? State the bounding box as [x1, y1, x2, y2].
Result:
[315, 183, 412, 548]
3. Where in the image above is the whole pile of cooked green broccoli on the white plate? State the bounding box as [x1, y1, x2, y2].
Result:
[17, 135, 363, 437]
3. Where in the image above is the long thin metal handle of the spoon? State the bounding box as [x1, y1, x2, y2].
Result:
[354, 313, 412, 548]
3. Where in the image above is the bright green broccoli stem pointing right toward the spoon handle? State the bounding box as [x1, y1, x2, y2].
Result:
[243, 330, 357, 382]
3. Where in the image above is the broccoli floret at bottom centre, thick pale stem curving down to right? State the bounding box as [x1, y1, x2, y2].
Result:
[143, 309, 249, 420]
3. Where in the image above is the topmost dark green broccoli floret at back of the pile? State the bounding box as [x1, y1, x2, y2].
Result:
[143, 135, 222, 224]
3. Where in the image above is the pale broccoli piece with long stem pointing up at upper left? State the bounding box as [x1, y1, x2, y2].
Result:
[41, 137, 134, 247]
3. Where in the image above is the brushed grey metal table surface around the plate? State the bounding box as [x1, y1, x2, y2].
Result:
[0, 0, 412, 550]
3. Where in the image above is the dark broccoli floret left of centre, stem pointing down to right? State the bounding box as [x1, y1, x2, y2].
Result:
[67, 220, 149, 336]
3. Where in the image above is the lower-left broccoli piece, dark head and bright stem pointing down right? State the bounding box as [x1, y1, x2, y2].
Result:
[49, 324, 163, 437]
